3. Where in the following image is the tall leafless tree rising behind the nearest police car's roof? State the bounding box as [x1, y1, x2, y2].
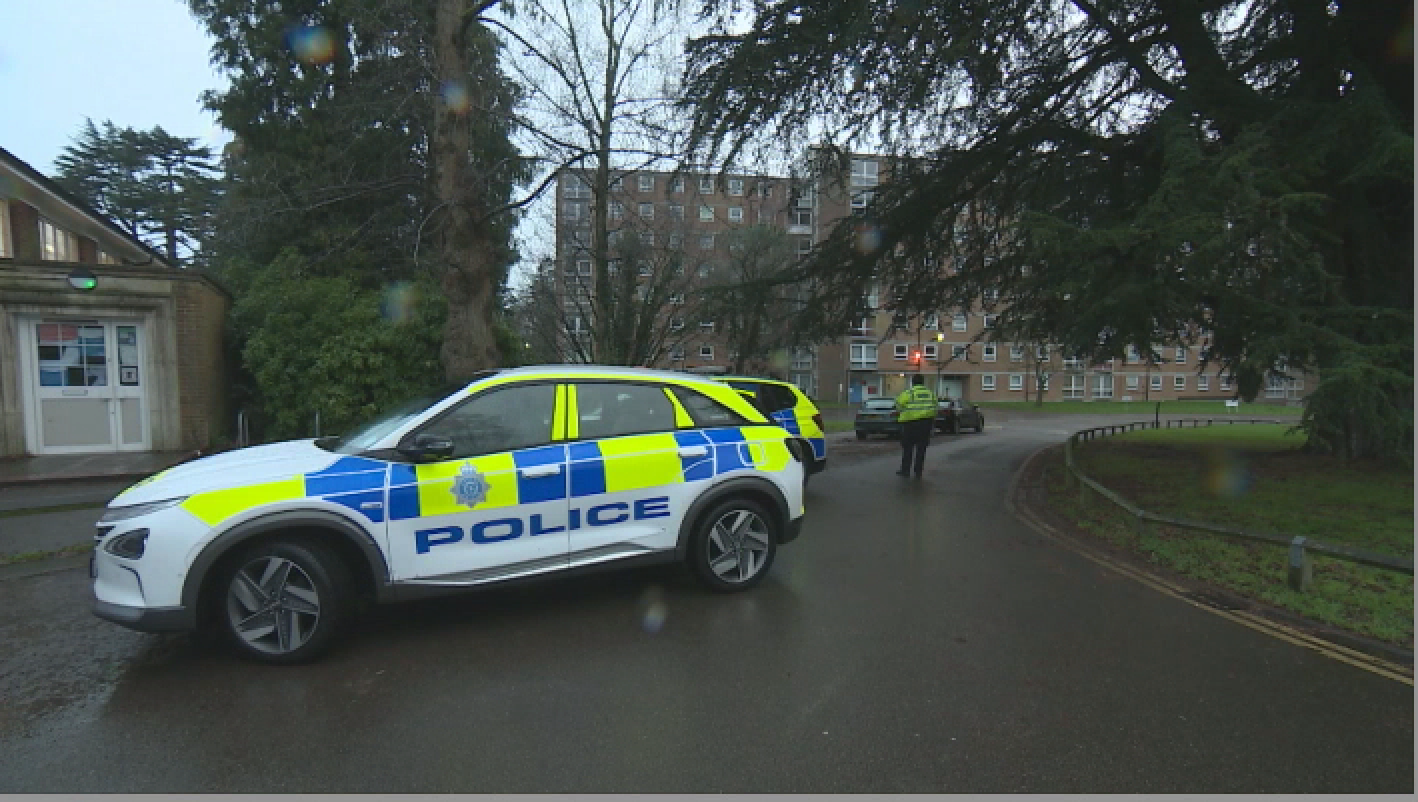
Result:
[492, 0, 681, 364]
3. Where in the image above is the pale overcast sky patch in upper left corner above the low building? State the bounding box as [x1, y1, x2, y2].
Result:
[0, 0, 230, 174]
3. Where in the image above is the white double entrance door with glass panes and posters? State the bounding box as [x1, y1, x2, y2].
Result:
[31, 320, 150, 453]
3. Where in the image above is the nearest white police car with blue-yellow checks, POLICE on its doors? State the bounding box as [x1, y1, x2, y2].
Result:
[92, 366, 813, 663]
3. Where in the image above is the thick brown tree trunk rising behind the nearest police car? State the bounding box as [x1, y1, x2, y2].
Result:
[430, 0, 501, 381]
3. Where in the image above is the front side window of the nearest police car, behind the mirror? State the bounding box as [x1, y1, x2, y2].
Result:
[420, 384, 556, 459]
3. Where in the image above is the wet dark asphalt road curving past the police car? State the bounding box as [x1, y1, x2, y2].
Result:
[0, 415, 1414, 792]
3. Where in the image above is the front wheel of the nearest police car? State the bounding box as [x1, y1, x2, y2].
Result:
[221, 540, 353, 665]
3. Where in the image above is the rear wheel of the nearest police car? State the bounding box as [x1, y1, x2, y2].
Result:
[691, 499, 778, 592]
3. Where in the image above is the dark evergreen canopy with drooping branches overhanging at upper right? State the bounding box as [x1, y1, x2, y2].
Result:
[688, 0, 1414, 455]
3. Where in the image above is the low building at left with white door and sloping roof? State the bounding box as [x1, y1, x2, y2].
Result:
[0, 149, 230, 458]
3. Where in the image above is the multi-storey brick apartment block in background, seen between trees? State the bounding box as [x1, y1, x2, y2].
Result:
[556, 156, 1305, 402]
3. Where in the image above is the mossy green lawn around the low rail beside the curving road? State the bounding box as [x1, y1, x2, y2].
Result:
[1048, 424, 1414, 648]
